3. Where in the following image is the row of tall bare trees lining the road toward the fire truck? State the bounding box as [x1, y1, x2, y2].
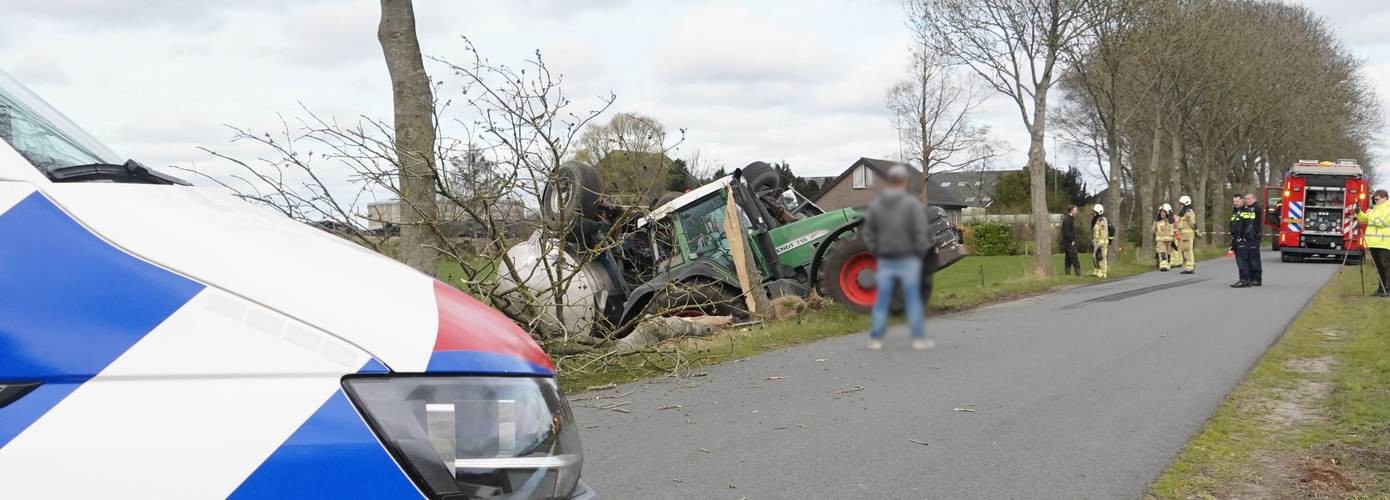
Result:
[890, 0, 1383, 275]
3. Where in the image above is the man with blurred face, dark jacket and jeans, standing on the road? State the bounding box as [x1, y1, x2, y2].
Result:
[860, 165, 935, 350]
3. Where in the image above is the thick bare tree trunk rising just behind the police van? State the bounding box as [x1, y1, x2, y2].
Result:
[377, 0, 442, 276]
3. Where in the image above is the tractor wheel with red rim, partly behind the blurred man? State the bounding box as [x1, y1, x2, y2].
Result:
[816, 235, 933, 314]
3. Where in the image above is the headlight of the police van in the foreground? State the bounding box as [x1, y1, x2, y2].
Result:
[343, 376, 584, 500]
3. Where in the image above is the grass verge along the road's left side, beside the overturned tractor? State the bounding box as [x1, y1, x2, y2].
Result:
[555, 245, 1225, 394]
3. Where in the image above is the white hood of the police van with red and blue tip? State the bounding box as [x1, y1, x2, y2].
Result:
[27, 182, 553, 376]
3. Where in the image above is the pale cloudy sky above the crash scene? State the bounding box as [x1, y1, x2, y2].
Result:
[0, 0, 1390, 190]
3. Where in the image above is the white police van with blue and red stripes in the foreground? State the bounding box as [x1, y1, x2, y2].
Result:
[0, 72, 596, 499]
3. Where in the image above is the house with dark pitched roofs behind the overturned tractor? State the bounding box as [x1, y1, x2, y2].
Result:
[812, 158, 1006, 219]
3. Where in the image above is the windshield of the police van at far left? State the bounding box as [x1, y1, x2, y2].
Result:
[0, 71, 124, 174]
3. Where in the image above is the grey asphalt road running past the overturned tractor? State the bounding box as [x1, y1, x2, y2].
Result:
[571, 250, 1339, 499]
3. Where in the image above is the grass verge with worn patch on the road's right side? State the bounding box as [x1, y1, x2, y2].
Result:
[1148, 261, 1390, 499]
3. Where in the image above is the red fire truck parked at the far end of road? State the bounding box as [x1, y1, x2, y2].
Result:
[1265, 160, 1369, 263]
